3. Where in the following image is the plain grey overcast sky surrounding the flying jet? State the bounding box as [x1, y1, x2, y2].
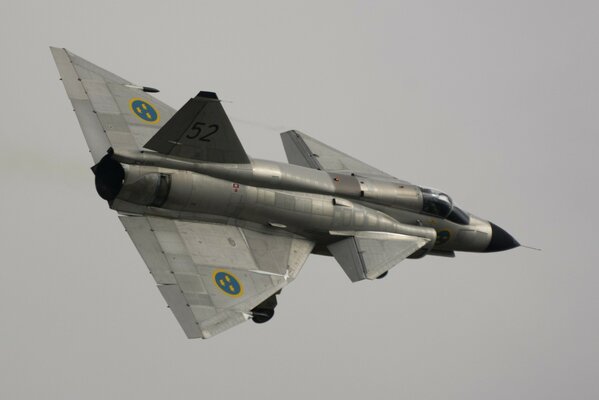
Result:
[0, 0, 599, 400]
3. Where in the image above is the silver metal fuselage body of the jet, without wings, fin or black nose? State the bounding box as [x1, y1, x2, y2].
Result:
[101, 152, 492, 257]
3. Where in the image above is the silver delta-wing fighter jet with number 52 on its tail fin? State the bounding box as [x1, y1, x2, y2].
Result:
[51, 48, 519, 338]
